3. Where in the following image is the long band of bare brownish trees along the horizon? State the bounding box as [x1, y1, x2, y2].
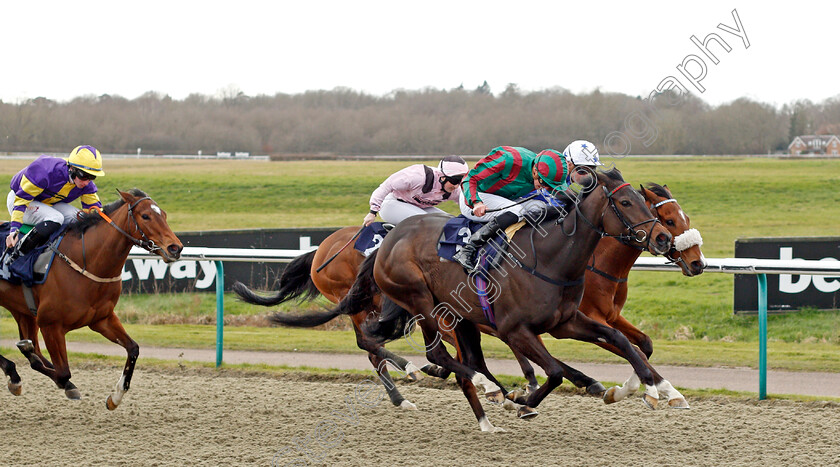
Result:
[0, 83, 840, 155]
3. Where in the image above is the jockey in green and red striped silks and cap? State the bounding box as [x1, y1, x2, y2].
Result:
[454, 146, 569, 271]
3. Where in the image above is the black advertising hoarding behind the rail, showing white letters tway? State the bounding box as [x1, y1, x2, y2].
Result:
[122, 228, 338, 293]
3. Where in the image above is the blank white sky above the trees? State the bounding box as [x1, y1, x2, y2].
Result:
[0, 0, 840, 106]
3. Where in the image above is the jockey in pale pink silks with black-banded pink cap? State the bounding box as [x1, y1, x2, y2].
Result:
[364, 156, 470, 226]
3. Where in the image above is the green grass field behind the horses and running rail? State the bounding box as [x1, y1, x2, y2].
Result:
[0, 157, 840, 371]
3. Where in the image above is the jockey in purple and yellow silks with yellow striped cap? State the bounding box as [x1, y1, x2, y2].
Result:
[6, 146, 105, 258]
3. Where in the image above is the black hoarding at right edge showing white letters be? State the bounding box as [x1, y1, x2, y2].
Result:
[734, 237, 840, 313]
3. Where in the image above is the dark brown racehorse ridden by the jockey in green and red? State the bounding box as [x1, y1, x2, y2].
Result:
[334, 169, 672, 431]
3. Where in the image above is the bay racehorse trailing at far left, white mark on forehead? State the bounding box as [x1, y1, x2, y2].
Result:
[0, 189, 184, 410]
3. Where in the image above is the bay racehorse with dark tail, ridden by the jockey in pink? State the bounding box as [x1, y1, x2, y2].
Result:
[233, 227, 436, 410]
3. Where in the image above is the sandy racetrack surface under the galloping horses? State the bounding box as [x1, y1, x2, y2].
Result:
[0, 366, 840, 466]
